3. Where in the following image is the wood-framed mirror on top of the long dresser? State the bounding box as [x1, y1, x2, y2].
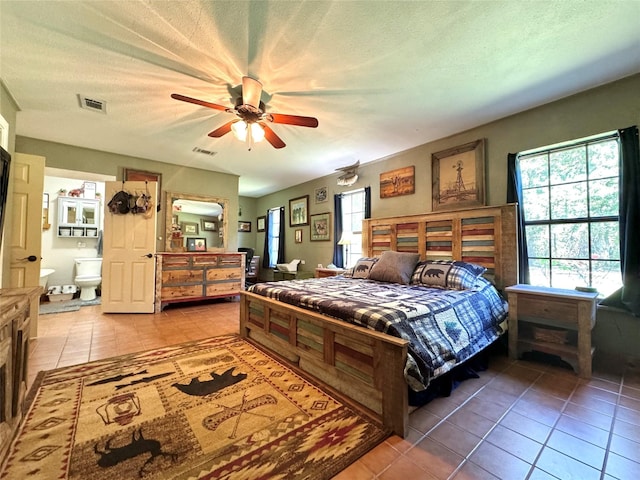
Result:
[165, 192, 229, 252]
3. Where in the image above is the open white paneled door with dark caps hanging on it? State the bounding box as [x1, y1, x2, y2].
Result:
[102, 182, 158, 313]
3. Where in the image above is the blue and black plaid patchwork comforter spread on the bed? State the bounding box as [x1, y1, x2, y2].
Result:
[248, 276, 508, 392]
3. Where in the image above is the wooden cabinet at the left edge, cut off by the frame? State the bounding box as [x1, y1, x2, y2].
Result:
[0, 287, 42, 463]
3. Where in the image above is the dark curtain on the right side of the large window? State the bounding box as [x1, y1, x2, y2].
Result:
[601, 126, 640, 317]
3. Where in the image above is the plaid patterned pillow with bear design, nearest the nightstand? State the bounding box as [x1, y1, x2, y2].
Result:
[411, 260, 487, 290]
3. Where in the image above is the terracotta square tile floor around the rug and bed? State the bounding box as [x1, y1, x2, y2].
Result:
[29, 301, 640, 480]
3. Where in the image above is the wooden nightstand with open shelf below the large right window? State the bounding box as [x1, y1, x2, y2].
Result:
[505, 285, 598, 378]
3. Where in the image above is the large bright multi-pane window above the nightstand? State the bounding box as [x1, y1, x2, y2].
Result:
[518, 133, 622, 296]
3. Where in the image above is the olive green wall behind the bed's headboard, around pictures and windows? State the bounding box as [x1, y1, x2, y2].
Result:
[256, 75, 640, 278]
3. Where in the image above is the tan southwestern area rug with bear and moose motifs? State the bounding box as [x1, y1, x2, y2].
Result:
[0, 336, 388, 480]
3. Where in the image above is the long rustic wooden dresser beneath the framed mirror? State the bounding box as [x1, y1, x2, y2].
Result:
[155, 252, 245, 312]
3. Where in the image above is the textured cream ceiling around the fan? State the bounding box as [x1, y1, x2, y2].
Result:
[0, 0, 640, 196]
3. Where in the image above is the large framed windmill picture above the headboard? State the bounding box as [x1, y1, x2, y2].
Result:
[431, 139, 485, 211]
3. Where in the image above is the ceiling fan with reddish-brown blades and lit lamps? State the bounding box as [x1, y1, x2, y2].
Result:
[171, 77, 318, 150]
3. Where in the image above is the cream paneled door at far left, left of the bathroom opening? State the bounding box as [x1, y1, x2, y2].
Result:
[7, 153, 45, 338]
